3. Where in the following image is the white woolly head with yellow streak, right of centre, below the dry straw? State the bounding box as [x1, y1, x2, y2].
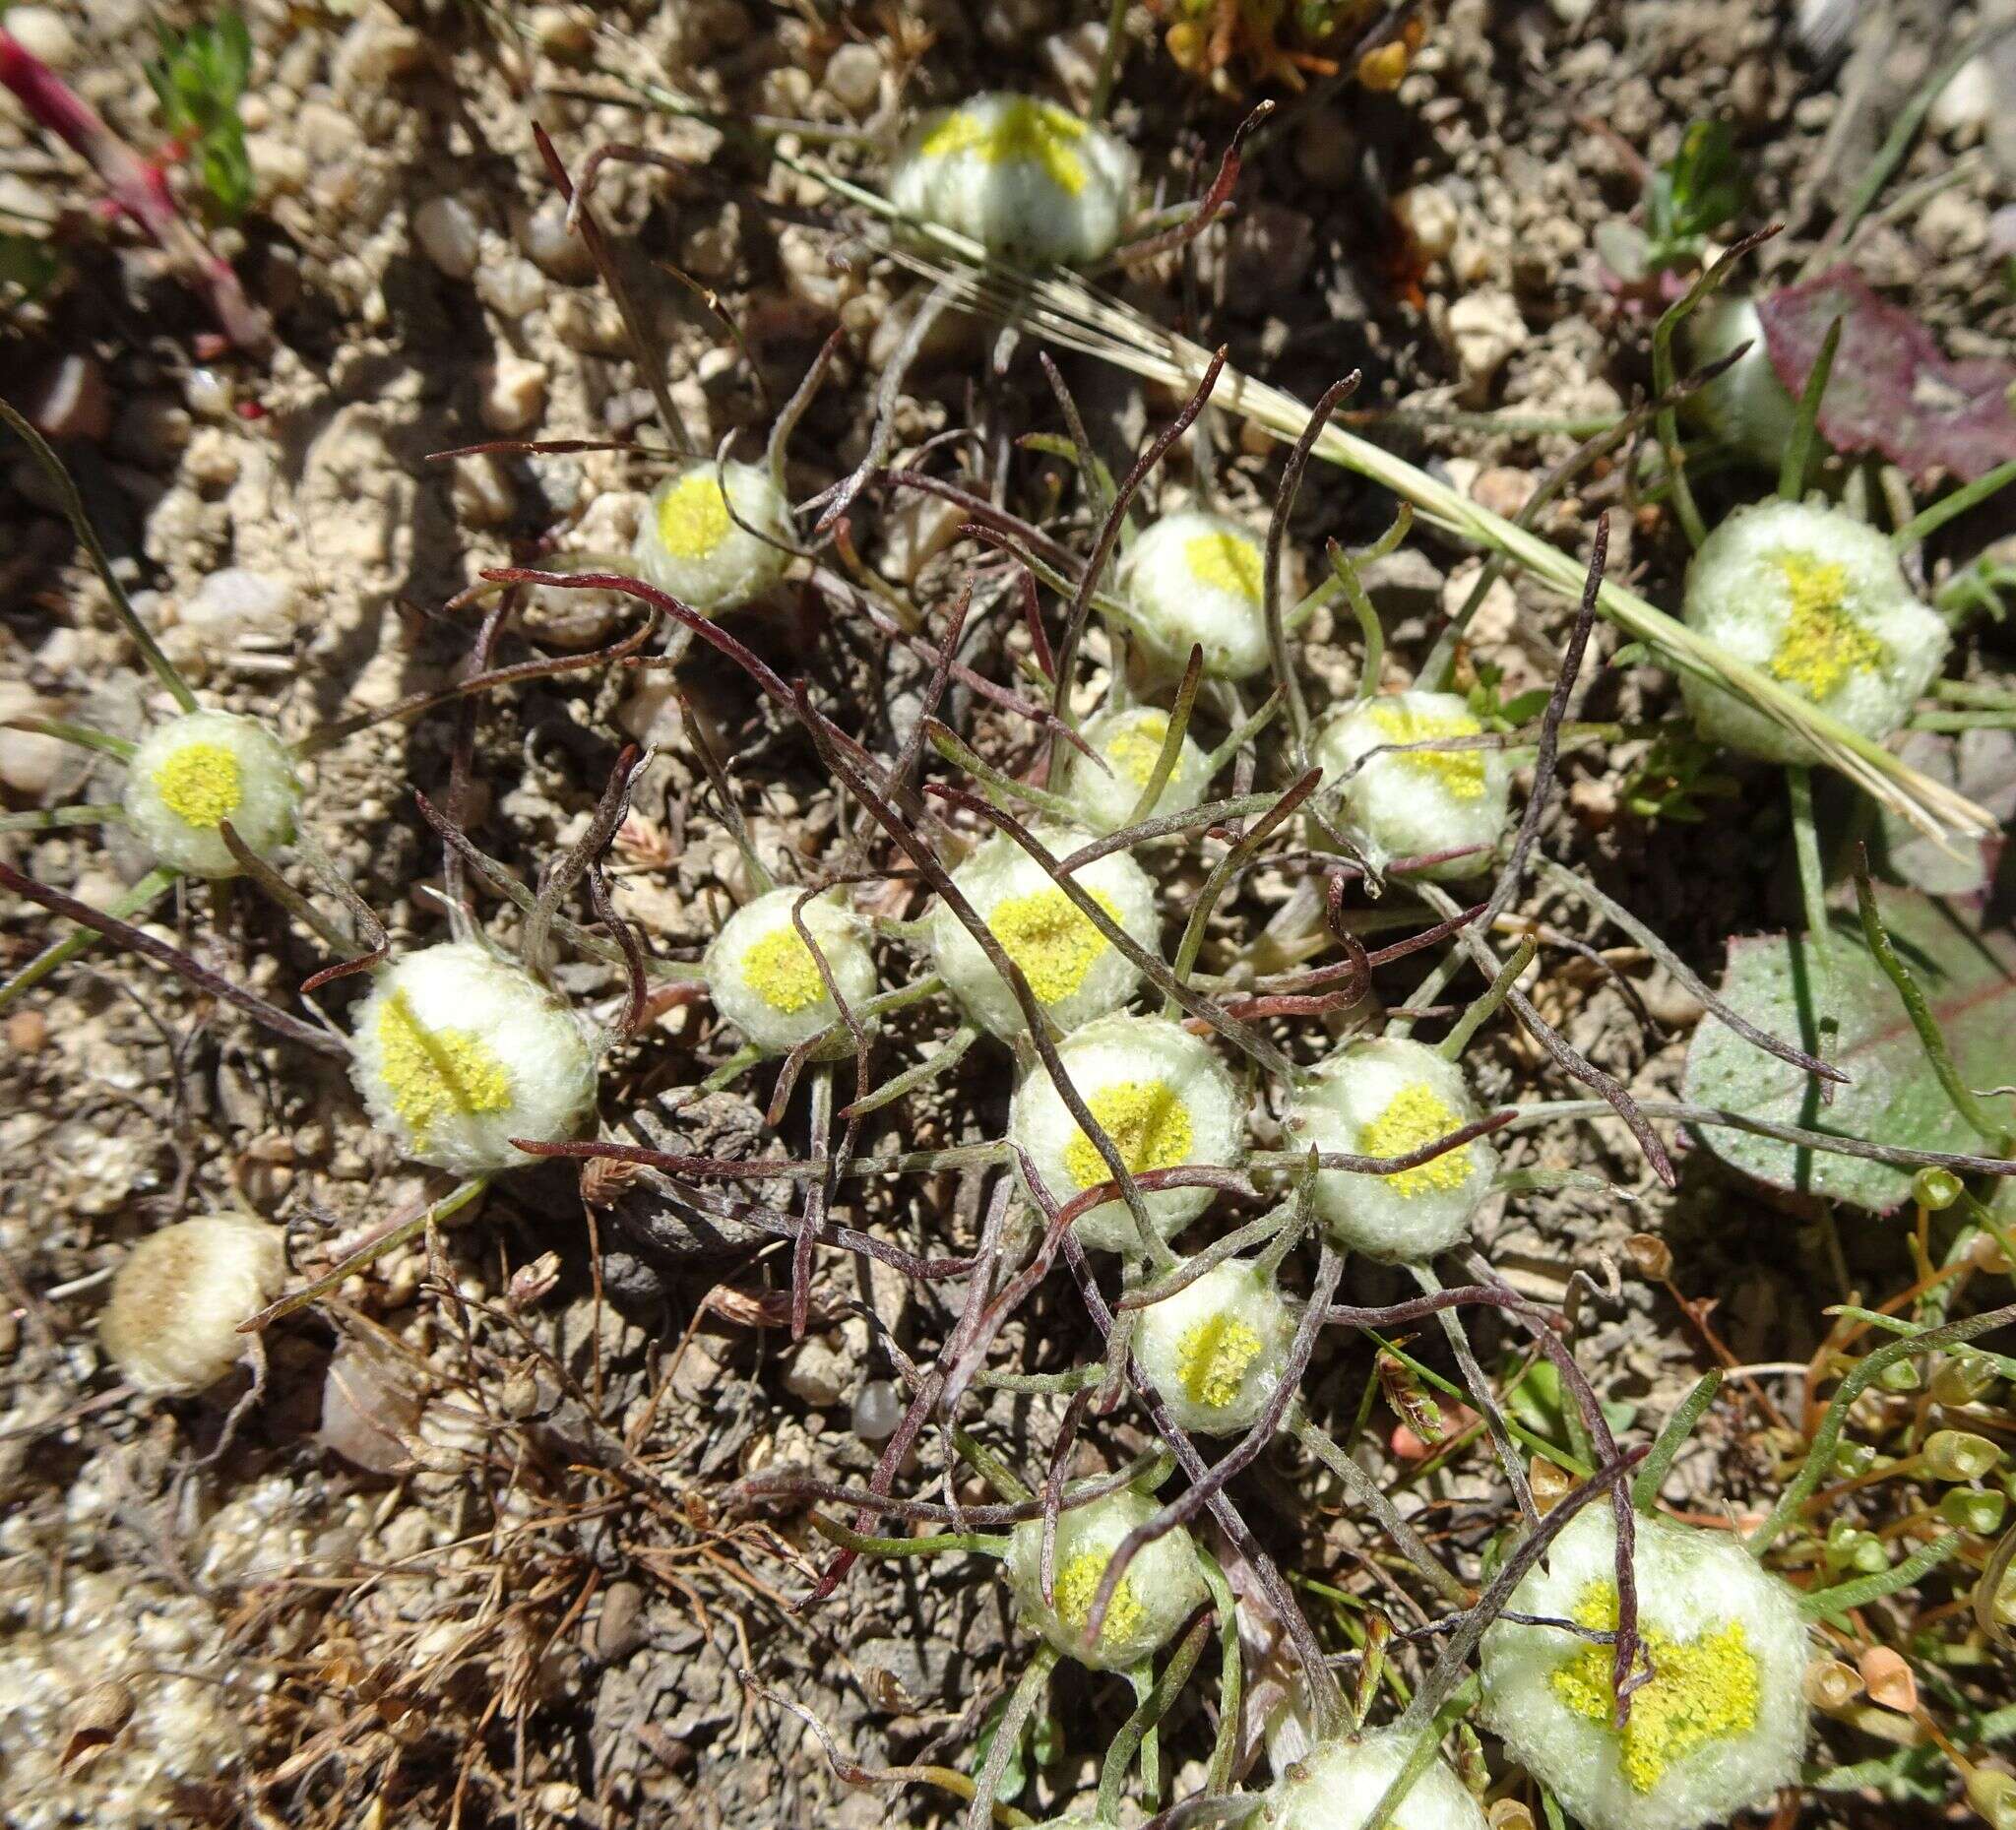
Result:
[1310, 691, 1512, 881]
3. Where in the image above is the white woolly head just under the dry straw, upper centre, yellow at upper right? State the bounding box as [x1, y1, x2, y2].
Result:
[1119, 508, 1268, 679]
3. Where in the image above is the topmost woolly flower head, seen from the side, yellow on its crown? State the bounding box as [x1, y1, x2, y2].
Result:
[889, 93, 1135, 266]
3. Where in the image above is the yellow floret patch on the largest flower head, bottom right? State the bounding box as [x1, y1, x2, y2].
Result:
[1550, 1582, 1758, 1792]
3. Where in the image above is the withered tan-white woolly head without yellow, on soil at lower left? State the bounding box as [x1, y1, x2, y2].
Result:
[98, 1214, 286, 1397]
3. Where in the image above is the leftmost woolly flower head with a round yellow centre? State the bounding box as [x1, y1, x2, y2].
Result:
[123, 712, 300, 877]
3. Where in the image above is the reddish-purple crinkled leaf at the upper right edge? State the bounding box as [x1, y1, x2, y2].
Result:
[1758, 266, 2016, 481]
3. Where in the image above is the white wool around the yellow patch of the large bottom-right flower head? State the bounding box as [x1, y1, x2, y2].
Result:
[1481, 1501, 1808, 1830]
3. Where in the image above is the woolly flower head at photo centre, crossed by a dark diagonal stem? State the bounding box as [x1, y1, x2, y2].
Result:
[929, 828, 1162, 1038]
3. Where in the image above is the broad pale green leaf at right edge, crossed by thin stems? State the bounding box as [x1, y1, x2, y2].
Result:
[1683, 889, 2016, 1214]
